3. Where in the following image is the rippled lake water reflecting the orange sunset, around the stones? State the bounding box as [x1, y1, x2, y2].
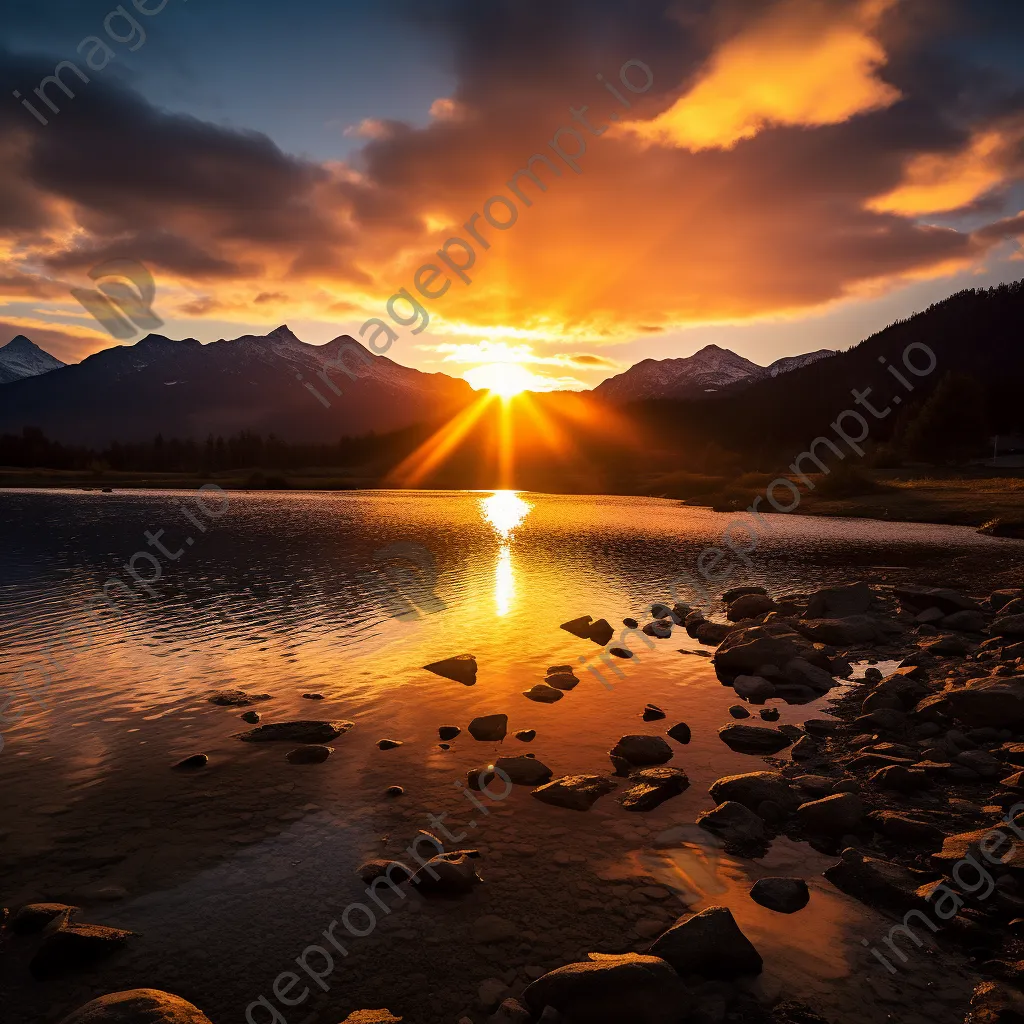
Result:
[0, 492, 1015, 1024]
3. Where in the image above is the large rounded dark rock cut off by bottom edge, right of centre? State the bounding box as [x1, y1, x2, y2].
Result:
[522, 953, 688, 1024]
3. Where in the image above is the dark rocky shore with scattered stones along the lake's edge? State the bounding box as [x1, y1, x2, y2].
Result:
[3, 583, 1024, 1024]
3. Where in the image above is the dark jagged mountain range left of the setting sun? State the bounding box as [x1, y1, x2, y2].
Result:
[0, 327, 473, 444]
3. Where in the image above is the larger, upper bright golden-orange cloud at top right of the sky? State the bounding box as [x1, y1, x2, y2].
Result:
[625, 0, 900, 151]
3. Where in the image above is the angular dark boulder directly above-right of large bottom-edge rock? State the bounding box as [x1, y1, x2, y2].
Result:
[650, 906, 763, 978]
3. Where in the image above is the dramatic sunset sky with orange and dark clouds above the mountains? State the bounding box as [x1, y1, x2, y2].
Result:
[0, 0, 1024, 389]
